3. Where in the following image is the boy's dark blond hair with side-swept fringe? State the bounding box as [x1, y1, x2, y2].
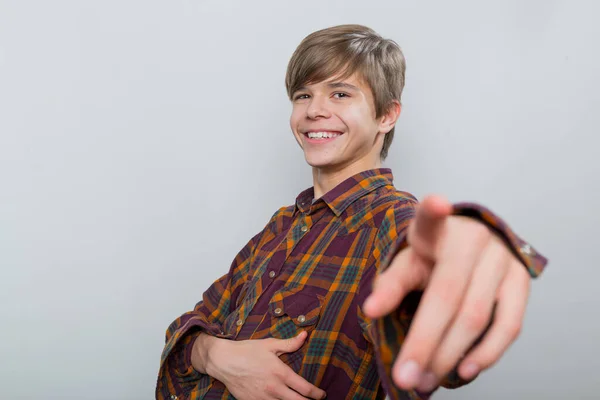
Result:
[285, 25, 406, 159]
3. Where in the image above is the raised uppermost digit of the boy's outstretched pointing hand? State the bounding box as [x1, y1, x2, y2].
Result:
[408, 195, 452, 261]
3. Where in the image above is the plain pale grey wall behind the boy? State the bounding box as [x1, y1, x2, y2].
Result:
[0, 0, 600, 399]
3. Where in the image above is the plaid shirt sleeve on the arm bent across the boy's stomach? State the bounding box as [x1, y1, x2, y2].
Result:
[156, 228, 262, 399]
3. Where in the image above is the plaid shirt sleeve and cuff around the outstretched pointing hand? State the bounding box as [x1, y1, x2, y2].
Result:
[362, 201, 547, 400]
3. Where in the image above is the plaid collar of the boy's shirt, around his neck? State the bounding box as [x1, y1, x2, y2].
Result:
[296, 168, 394, 217]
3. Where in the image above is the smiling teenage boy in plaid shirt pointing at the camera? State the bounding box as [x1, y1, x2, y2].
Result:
[156, 25, 547, 400]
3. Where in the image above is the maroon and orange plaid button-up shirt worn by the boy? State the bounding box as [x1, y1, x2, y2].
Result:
[156, 169, 547, 400]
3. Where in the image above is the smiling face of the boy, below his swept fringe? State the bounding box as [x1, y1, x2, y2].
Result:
[290, 75, 397, 172]
